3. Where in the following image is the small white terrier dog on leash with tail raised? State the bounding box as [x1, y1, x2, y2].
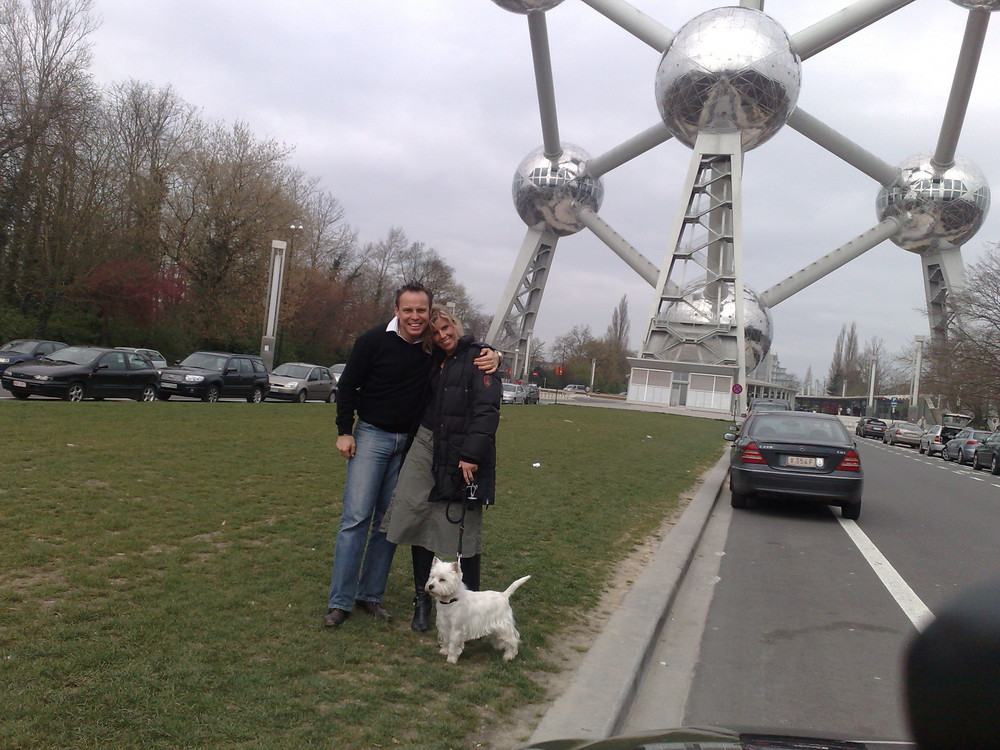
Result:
[424, 557, 531, 664]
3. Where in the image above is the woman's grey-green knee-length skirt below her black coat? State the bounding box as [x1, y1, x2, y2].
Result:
[381, 427, 483, 558]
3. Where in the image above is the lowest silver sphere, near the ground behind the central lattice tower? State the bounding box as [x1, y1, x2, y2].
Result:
[657, 279, 773, 372]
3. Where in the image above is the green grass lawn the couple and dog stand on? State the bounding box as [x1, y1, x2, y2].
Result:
[0, 400, 725, 749]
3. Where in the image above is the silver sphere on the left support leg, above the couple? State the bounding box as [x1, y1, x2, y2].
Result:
[511, 143, 604, 237]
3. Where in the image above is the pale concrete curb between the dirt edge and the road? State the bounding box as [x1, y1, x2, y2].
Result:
[530, 452, 729, 743]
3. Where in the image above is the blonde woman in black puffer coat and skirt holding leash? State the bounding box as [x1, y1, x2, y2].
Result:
[382, 307, 503, 632]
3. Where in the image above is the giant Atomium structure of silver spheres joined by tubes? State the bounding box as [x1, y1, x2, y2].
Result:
[488, 0, 1000, 418]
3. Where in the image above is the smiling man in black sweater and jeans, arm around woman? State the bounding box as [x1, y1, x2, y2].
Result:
[323, 284, 500, 627]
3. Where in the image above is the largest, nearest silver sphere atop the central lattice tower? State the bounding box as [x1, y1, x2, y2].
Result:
[656, 7, 802, 151]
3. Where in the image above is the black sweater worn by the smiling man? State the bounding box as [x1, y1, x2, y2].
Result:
[337, 325, 431, 435]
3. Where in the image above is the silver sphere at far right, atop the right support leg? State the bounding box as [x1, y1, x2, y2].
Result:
[875, 154, 990, 253]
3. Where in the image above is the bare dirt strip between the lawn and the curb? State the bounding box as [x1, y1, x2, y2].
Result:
[469, 490, 701, 750]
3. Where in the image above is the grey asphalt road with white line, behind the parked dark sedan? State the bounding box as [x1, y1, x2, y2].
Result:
[625, 440, 1000, 740]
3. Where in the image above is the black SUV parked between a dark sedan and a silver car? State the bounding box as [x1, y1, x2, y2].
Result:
[157, 352, 269, 404]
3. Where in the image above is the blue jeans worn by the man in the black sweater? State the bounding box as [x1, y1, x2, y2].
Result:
[327, 420, 407, 612]
